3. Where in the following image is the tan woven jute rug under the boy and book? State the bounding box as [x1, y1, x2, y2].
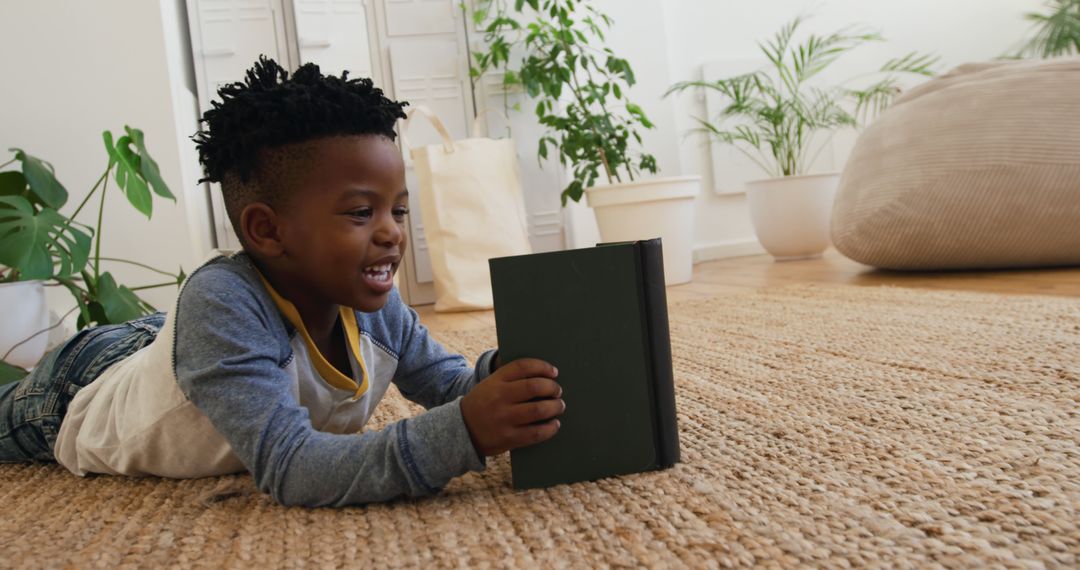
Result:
[0, 286, 1080, 568]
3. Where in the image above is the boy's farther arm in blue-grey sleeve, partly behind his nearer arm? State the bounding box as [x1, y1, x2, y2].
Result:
[387, 291, 499, 408]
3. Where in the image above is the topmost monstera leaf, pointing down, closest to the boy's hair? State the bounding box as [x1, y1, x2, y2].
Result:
[102, 126, 176, 218]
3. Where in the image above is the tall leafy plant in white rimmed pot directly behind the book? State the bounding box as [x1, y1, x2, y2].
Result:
[471, 0, 701, 285]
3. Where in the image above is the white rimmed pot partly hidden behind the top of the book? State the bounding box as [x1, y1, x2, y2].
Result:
[585, 176, 701, 285]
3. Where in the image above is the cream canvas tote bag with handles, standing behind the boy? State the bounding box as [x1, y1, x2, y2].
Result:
[402, 106, 532, 312]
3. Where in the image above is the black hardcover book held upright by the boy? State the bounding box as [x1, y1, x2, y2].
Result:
[489, 239, 679, 489]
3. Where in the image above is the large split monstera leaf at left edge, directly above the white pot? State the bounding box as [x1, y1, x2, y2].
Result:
[0, 195, 91, 280]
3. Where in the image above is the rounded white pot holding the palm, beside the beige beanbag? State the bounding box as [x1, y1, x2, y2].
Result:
[746, 173, 840, 261]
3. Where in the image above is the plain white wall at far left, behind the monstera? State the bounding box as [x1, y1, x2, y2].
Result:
[0, 0, 211, 312]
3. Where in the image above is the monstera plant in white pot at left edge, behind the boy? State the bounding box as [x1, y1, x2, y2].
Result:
[0, 126, 185, 383]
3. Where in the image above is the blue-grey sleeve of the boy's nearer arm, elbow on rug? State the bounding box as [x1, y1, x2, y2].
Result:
[174, 267, 484, 506]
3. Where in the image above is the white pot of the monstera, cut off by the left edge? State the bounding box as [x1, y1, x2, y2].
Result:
[0, 281, 49, 368]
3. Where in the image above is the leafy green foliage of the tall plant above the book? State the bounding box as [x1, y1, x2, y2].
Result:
[464, 0, 651, 200]
